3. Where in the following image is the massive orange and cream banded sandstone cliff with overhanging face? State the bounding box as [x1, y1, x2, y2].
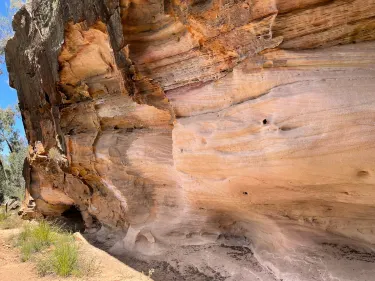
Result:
[7, 0, 375, 281]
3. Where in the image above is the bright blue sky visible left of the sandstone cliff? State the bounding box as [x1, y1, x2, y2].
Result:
[0, 0, 24, 138]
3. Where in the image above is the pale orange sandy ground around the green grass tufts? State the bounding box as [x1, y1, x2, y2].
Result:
[0, 230, 151, 281]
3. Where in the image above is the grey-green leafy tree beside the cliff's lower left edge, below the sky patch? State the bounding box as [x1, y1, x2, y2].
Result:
[0, 107, 27, 203]
